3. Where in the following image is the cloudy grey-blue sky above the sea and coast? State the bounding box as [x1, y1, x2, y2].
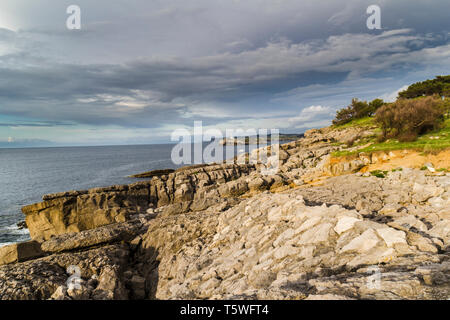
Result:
[0, 0, 450, 147]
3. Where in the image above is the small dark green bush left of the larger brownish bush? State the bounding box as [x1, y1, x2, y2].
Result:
[333, 98, 384, 125]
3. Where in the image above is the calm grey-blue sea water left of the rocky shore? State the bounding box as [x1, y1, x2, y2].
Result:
[0, 144, 256, 246]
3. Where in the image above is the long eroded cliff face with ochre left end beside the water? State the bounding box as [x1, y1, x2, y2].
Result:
[22, 165, 255, 241]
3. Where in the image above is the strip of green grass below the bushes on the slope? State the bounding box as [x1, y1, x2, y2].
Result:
[333, 119, 450, 156]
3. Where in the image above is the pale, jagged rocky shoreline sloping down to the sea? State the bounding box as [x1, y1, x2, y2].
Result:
[0, 127, 450, 300]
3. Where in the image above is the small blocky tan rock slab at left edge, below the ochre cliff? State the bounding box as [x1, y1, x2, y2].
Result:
[0, 241, 44, 265]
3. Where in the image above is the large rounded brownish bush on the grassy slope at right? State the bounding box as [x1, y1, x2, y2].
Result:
[375, 97, 445, 142]
